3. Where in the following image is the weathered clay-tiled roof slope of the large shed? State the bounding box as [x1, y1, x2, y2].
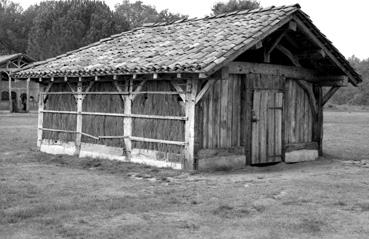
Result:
[12, 5, 360, 84]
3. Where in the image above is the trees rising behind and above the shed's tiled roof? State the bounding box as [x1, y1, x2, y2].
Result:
[0, 0, 260, 60]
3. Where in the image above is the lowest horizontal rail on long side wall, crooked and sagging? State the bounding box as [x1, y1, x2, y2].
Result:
[39, 128, 186, 146]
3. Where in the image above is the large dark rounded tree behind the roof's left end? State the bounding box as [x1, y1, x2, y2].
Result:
[27, 0, 127, 60]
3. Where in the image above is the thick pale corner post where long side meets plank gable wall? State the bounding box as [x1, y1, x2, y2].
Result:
[183, 79, 198, 170]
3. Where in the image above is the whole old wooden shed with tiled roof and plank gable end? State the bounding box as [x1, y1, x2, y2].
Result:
[14, 5, 361, 169]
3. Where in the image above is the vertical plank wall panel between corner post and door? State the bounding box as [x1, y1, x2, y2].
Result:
[195, 75, 244, 151]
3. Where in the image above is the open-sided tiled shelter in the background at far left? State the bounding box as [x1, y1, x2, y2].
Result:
[0, 53, 39, 112]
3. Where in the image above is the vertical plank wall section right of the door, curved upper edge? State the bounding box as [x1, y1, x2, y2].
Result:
[284, 79, 313, 145]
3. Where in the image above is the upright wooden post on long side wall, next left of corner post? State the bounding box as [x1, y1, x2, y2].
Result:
[123, 79, 133, 160]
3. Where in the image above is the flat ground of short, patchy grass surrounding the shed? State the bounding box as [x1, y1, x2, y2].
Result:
[0, 112, 369, 239]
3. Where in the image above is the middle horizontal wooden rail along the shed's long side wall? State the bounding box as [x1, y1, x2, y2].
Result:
[40, 110, 187, 121]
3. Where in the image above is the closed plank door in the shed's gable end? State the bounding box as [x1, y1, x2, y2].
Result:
[251, 90, 283, 164]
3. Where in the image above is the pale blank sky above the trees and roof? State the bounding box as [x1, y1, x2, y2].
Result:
[13, 0, 369, 59]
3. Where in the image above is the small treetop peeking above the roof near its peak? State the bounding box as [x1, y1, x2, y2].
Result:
[211, 0, 260, 15]
